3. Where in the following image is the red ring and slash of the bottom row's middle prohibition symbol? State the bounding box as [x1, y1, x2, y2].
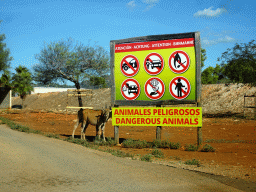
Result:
[144, 77, 165, 100]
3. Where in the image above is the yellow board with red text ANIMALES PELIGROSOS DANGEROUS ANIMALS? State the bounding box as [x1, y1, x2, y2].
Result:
[112, 107, 202, 127]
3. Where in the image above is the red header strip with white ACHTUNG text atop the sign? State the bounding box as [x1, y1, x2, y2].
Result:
[115, 38, 195, 53]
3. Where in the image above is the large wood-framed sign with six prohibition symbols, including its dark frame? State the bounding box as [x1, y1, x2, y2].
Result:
[110, 32, 201, 106]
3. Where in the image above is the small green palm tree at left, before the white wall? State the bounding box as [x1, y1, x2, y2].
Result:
[12, 65, 33, 108]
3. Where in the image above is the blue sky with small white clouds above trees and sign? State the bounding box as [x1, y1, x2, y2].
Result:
[0, 0, 256, 84]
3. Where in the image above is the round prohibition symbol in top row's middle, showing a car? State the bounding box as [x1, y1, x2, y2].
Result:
[144, 53, 164, 75]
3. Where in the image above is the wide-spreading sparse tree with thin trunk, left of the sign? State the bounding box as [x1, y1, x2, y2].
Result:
[33, 39, 109, 107]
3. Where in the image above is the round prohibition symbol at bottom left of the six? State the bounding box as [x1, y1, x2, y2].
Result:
[121, 79, 140, 100]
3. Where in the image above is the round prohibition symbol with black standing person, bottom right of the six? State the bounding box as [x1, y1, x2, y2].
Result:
[169, 76, 191, 100]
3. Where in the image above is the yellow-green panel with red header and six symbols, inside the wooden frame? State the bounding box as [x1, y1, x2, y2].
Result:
[114, 38, 197, 101]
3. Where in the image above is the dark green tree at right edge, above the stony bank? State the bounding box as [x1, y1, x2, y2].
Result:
[218, 40, 256, 85]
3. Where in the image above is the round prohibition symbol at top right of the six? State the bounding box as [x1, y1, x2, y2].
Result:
[169, 50, 190, 74]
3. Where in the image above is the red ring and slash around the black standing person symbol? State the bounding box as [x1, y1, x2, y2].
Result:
[169, 76, 191, 100]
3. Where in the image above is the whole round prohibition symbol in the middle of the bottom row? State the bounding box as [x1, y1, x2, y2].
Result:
[144, 77, 165, 100]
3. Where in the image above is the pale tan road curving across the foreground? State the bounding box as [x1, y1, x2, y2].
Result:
[0, 125, 250, 192]
